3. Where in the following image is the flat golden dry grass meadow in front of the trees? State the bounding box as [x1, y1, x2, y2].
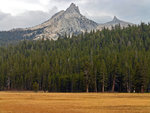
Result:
[0, 92, 150, 113]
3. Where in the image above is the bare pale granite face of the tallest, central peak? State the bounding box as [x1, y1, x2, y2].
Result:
[30, 3, 98, 40]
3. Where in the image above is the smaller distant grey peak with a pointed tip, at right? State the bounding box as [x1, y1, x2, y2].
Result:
[97, 16, 134, 30]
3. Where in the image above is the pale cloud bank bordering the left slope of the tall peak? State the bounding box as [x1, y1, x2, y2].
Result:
[0, 7, 58, 30]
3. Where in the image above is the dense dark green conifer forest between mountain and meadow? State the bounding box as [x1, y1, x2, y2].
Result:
[0, 23, 150, 92]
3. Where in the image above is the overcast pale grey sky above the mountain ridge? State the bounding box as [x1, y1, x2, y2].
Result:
[0, 0, 150, 31]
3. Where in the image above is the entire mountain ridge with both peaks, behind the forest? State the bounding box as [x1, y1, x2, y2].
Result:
[0, 3, 133, 45]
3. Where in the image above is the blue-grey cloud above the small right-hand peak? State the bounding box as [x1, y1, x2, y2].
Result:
[79, 0, 150, 23]
